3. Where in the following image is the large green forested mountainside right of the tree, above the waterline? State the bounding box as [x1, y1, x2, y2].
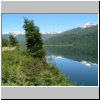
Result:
[45, 25, 98, 45]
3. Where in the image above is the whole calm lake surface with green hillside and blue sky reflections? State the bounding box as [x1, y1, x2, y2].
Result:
[45, 46, 98, 86]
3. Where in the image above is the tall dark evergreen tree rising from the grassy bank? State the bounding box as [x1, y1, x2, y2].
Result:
[23, 18, 45, 58]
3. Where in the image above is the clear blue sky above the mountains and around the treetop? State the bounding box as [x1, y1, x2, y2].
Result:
[2, 14, 98, 34]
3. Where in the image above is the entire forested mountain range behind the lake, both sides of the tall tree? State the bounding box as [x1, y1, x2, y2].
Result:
[2, 24, 98, 45]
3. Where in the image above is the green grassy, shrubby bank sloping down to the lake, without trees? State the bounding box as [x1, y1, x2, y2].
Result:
[2, 49, 74, 86]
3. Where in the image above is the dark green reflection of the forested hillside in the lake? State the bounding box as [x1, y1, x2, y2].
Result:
[45, 46, 98, 63]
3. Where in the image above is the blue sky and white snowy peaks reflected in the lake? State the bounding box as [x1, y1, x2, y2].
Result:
[46, 53, 98, 86]
